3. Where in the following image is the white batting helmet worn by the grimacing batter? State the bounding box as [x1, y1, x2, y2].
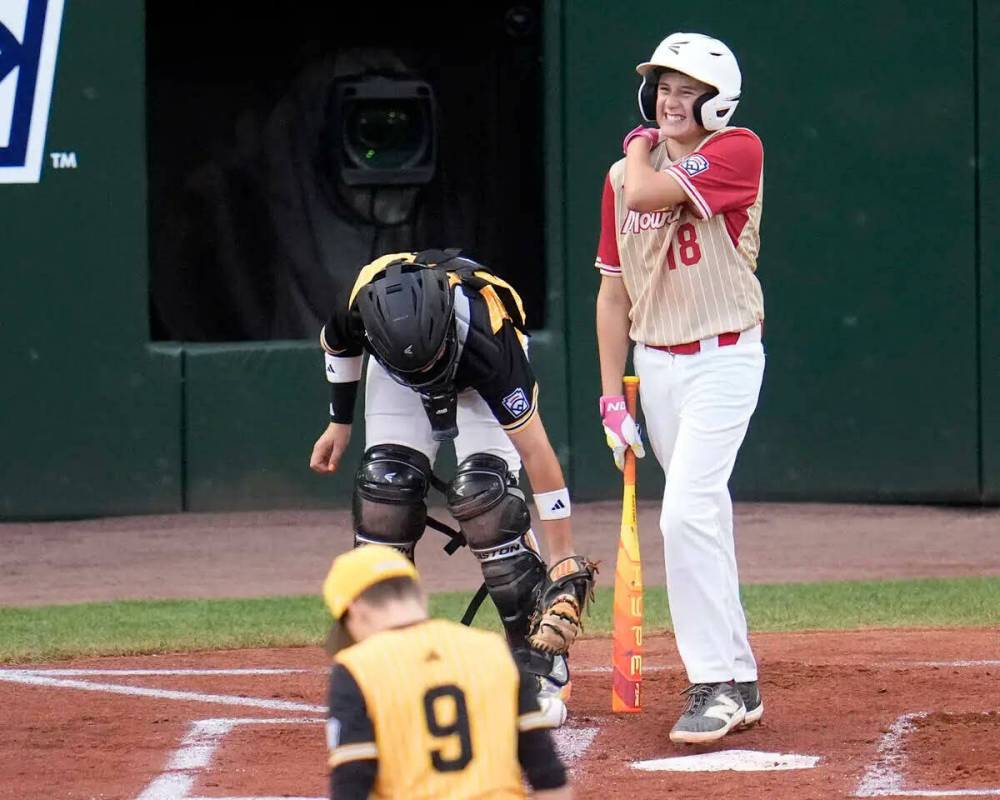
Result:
[635, 33, 743, 131]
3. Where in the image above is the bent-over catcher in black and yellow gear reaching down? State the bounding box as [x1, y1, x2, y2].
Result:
[309, 250, 596, 700]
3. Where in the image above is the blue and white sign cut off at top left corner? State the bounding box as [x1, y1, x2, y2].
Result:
[0, 0, 63, 183]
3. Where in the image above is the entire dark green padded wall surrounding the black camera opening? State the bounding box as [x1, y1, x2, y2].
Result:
[0, 0, 1000, 519]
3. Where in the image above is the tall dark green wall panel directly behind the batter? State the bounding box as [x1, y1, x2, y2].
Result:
[562, 0, 980, 501]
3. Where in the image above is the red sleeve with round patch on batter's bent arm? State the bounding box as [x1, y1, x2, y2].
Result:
[666, 129, 764, 219]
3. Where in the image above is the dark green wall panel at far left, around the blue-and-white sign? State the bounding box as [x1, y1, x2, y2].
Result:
[0, 0, 181, 519]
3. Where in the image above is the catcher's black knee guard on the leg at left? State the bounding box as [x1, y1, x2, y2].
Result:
[353, 444, 431, 559]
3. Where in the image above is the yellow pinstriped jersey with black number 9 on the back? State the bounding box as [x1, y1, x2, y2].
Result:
[328, 620, 548, 800]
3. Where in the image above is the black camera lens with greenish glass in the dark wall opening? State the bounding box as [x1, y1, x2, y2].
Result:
[346, 100, 426, 169]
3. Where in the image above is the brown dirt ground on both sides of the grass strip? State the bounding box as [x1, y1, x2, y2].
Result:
[0, 503, 1000, 800]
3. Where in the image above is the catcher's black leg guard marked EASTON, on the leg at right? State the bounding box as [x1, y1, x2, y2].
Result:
[448, 453, 545, 647]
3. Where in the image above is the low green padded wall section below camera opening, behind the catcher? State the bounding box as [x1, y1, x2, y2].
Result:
[184, 332, 565, 511]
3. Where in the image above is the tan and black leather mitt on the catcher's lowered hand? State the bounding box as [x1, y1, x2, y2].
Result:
[528, 556, 597, 655]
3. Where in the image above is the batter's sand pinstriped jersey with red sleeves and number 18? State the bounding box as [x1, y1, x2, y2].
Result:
[595, 128, 764, 345]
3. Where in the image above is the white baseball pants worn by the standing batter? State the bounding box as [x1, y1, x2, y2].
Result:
[633, 328, 764, 683]
